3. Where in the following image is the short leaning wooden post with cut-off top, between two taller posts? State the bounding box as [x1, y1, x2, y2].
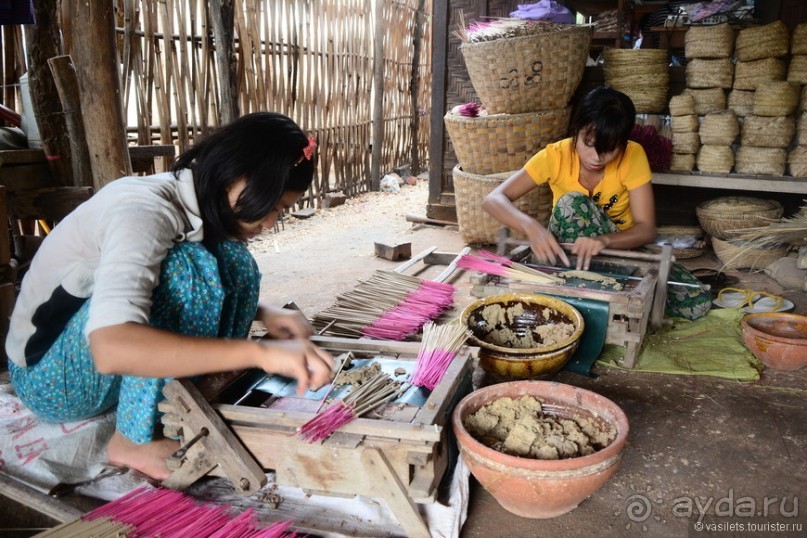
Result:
[48, 56, 93, 187]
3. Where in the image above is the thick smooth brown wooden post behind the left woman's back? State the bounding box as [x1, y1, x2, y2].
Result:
[68, 2, 132, 191]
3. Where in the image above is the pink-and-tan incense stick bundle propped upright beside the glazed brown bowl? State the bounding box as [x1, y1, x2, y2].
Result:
[412, 320, 471, 390]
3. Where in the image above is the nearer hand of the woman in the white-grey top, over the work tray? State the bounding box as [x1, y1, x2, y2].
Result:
[259, 338, 333, 395]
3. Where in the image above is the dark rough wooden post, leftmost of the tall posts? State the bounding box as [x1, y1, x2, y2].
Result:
[23, 0, 74, 186]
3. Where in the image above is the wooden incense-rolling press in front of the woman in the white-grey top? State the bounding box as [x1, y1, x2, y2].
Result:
[160, 336, 473, 537]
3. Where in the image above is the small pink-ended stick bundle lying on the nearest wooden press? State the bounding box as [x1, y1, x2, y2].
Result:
[298, 372, 407, 443]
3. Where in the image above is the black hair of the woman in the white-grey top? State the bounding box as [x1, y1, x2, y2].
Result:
[171, 112, 314, 244]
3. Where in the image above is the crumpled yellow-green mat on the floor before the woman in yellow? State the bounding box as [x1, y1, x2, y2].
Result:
[599, 308, 763, 383]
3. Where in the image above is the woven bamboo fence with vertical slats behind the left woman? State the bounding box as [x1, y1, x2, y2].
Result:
[0, 0, 432, 206]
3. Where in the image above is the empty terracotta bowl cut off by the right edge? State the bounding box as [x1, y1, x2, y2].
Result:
[740, 312, 807, 370]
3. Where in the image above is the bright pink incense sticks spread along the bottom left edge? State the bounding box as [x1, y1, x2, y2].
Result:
[36, 486, 298, 538]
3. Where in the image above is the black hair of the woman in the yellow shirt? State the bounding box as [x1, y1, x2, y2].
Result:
[569, 86, 636, 154]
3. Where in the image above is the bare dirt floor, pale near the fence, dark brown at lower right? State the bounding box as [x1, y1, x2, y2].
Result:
[0, 180, 807, 538]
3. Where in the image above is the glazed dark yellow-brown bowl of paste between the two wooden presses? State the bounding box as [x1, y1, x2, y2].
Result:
[462, 293, 585, 379]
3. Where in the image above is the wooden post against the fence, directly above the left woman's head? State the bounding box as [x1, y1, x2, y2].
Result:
[210, 0, 238, 125]
